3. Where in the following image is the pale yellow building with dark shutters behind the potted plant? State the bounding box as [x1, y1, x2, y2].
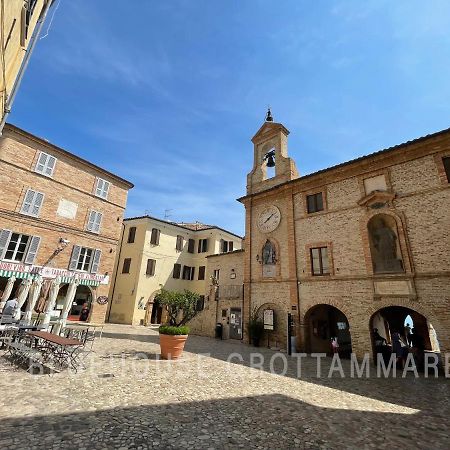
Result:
[108, 216, 242, 325]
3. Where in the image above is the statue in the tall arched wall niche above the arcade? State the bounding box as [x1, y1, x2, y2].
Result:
[371, 218, 403, 272]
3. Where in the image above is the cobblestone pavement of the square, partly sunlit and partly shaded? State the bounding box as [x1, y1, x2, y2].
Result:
[0, 325, 450, 450]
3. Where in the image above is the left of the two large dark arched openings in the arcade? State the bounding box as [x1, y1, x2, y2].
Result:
[303, 301, 352, 357]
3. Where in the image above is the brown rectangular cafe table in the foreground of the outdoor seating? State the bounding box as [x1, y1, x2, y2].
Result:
[27, 331, 83, 370]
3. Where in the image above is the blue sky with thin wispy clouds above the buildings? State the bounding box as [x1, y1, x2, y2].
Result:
[9, 0, 450, 234]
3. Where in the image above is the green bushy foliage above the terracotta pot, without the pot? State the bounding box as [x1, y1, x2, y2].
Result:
[157, 289, 200, 327]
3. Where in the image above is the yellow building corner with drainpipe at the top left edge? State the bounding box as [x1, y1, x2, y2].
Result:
[0, 0, 53, 133]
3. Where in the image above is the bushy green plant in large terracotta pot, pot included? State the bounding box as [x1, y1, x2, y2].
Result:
[157, 289, 200, 359]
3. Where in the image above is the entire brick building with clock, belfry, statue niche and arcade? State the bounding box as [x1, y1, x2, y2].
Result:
[196, 114, 450, 357]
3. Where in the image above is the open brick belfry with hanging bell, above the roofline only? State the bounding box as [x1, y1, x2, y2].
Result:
[247, 108, 299, 195]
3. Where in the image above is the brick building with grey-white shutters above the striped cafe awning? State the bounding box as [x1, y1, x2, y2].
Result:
[0, 125, 133, 322]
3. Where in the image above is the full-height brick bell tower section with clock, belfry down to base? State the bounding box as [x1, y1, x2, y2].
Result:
[239, 109, 299, 348]
